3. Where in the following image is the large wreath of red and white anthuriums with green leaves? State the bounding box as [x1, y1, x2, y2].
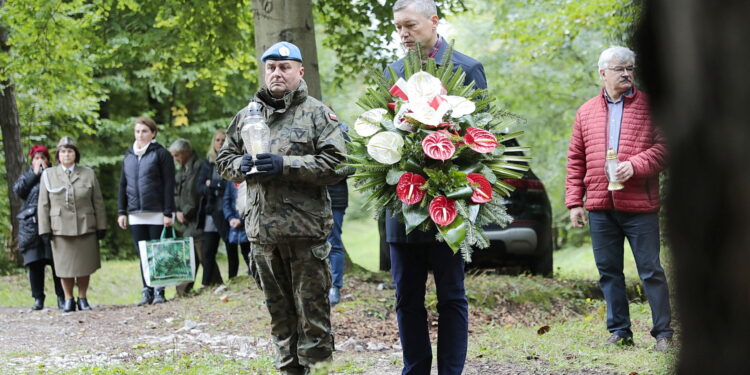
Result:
[347, 51, 529, 261]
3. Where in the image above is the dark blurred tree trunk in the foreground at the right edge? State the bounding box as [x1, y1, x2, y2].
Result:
[636, 0, 750, 374]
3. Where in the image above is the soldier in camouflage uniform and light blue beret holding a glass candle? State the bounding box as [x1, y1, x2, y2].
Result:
[216, 42, 345, 374]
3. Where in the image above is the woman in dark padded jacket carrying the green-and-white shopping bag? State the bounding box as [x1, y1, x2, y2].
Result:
[117, 117, 175, 306]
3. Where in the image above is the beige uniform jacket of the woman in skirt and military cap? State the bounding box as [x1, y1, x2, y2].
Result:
[37, 165, 107, 236]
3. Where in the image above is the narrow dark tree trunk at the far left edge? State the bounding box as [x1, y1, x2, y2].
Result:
[0, 0, 24, 264]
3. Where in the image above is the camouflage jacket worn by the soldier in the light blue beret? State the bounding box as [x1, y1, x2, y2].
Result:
[216, 80, 346, 244]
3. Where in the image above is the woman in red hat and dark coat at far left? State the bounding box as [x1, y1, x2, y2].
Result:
[13, 145, 65, 310]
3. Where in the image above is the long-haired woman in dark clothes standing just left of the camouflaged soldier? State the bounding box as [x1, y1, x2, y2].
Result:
[195, 130, 229, 286]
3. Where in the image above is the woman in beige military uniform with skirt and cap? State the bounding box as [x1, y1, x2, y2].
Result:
[37, 137, 107, 312]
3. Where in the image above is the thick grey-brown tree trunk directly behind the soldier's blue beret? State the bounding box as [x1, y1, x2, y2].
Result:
[253, 0, 321, 99]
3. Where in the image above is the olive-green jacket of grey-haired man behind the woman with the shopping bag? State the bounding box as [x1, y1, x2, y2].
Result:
[174, 151, 204, 237]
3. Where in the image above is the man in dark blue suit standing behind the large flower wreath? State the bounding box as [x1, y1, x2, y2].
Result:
[385, 0, 487, 375]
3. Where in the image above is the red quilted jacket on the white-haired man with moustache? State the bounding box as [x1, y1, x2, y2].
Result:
[565, 88, 667, 212]
